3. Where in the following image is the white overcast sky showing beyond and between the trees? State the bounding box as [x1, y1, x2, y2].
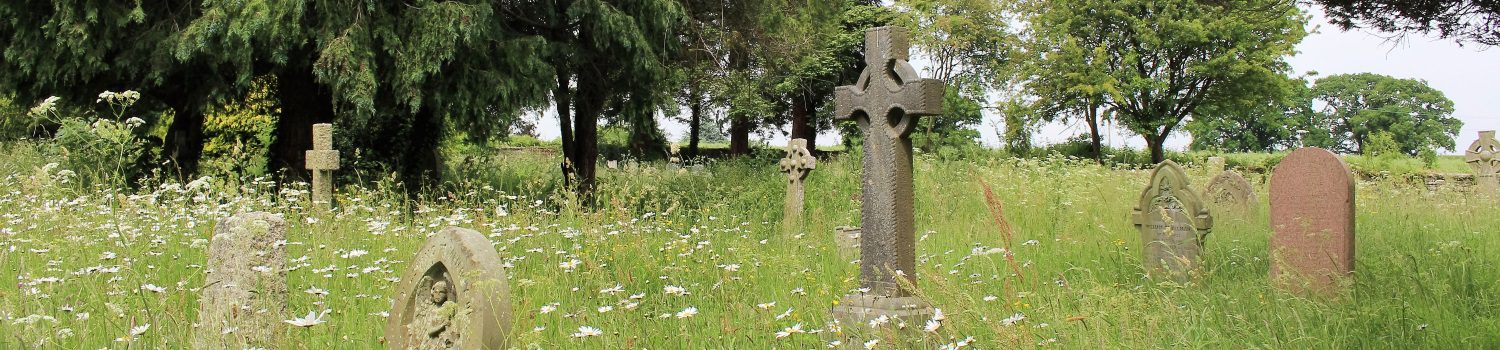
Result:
[537, 9, 1500, 153]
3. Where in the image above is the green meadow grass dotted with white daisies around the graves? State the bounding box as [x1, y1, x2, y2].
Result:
[0, 143, 1500, 348]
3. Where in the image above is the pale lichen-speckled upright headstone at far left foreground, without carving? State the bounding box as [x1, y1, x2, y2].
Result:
[192, 212, 287, 348]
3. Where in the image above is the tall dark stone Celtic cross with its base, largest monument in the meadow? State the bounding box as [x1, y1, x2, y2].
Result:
[834, 27, 945, 324]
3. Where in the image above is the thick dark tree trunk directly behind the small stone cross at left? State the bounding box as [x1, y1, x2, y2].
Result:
[267, 68, 338, 180]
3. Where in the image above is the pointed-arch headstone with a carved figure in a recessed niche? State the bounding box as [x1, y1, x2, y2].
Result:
[386, 227, 510, 350]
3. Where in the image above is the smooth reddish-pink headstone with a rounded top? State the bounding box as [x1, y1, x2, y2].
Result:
[1271, 147, 1355, 293]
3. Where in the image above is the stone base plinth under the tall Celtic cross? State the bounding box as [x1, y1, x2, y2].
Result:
[833, 294, 933, 330]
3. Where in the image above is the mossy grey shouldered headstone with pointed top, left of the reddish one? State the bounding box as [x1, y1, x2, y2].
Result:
[1131, 161, 1214, 282]
